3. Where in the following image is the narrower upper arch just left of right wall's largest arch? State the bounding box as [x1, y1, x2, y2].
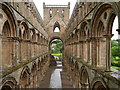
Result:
[79, 20, 91, 62]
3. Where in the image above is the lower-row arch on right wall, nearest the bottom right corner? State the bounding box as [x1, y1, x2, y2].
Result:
[91, 77, 109, 90]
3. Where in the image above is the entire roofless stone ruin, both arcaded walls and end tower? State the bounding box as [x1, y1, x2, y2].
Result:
[0, 0, 120, 90]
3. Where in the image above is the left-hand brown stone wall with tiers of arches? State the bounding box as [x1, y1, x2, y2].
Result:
[0, 2, 49, 88]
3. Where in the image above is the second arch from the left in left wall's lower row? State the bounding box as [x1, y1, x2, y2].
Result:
[20, 66, 30, 88]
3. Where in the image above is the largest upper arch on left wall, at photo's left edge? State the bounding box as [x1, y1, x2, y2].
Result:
[0, 3, 18, 68]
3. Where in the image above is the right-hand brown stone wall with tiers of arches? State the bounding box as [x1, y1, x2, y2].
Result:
[64, 2, 120, 89]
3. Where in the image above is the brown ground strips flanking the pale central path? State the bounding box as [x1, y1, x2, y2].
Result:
[39, 67, 73, 88]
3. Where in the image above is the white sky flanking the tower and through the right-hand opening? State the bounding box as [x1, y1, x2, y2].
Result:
[33, 0, 118, 40]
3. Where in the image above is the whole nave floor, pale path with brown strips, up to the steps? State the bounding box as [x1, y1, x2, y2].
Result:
[39, 60, 73, 88]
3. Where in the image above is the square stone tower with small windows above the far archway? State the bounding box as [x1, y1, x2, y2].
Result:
[43, 2, 70, 39]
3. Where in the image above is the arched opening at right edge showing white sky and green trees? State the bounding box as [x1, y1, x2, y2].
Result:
[111, 16, 120, 71]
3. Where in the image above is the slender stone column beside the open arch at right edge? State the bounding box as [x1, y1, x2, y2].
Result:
[104, 34, 113, 71]
